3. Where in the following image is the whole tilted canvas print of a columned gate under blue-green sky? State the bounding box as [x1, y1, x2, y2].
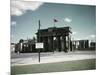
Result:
[10, 0, 96, 75]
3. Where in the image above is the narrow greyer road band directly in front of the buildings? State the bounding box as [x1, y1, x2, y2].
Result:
[11, 51, 95, 59]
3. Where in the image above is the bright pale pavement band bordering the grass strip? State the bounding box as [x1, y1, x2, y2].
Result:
[11, 51, 96, 66]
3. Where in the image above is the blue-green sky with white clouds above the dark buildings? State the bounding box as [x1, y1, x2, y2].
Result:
[11, 1, 96, 43]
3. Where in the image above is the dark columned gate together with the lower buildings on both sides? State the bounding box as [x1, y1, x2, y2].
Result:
[15, 27, 96, 52]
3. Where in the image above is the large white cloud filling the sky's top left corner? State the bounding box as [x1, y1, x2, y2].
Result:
[11, 0, 43, 16]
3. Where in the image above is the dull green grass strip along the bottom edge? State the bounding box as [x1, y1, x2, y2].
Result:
[11, 59, 96, 75]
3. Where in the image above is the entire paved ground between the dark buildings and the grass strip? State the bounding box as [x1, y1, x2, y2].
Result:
[11, 51, 96, 66]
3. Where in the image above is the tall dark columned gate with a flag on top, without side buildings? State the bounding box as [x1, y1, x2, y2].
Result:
[36, 27, 72, 52]
